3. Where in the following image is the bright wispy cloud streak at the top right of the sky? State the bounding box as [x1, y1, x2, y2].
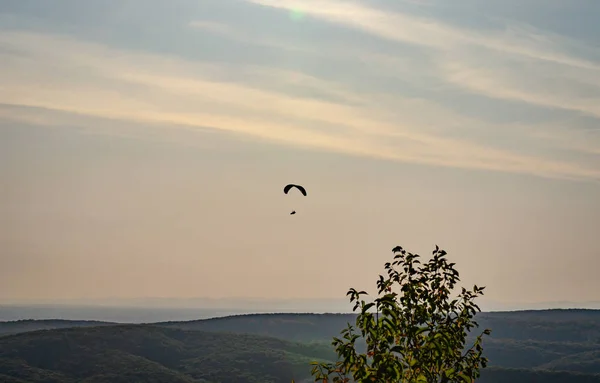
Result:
[248, 0, 600, 117]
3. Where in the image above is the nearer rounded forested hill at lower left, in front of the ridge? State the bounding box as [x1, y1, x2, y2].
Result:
[0, 325, 600, 383]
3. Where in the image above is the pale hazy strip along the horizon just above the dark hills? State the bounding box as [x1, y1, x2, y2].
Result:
[0, 297, 600, 323]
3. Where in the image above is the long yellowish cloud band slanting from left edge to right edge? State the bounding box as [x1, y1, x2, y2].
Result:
[0, 23, 600, 182]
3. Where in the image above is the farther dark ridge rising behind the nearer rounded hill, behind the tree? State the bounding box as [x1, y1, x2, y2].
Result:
[158, 310, 600, 373]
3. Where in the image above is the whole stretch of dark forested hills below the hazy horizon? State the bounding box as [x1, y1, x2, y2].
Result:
[0, 316, 600, 383]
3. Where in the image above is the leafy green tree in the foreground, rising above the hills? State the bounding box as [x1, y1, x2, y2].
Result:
[312, 245, 491, 383]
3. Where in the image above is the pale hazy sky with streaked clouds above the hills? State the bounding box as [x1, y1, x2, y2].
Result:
[0, 0, 600, 312]
